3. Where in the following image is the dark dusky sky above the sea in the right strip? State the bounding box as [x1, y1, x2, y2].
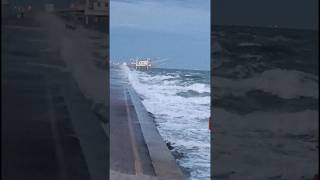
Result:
[212, 0, 319, 29]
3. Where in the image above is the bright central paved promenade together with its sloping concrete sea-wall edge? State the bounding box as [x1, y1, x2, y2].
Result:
[110, 68, 183, 180]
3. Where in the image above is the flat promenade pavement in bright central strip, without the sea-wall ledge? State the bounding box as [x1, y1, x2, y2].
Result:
[110, 69, 155, 179]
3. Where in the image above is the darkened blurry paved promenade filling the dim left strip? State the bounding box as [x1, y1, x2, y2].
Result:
[1, 13, 109, 180]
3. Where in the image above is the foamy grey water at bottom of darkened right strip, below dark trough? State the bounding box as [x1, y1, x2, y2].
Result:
[213, 108, 319, 179]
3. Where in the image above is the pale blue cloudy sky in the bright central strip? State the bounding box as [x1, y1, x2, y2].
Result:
[110, 0, 210, 70]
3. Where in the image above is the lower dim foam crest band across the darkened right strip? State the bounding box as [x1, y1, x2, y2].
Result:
[213, 108, 319, 135]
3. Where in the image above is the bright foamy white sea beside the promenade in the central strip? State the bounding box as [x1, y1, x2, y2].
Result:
[121, 65, 210, 180]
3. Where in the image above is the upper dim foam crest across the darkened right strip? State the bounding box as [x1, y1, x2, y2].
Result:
[213, 69, 319, 99]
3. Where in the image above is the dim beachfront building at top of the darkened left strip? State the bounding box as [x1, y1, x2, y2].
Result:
[84, 0, 109, 29]
